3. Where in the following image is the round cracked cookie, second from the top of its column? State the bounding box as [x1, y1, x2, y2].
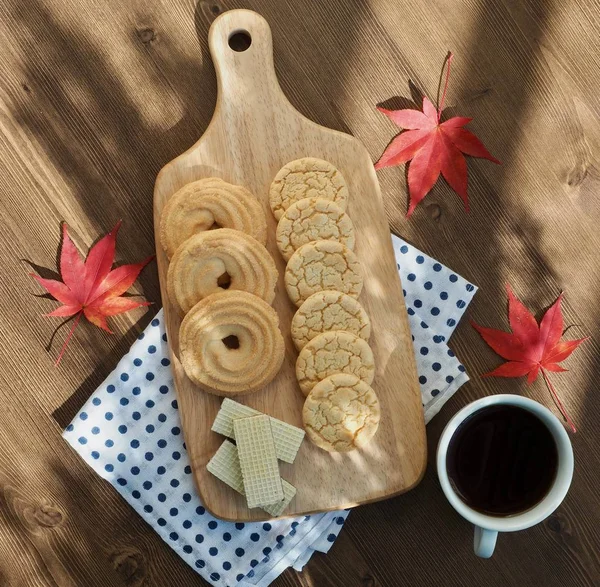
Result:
[277, 198, 354, 261]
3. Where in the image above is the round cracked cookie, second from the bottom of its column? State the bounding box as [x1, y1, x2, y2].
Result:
[296, 330, 375, 395]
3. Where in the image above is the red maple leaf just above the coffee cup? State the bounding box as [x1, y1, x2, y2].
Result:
[471, 284, 589, 432]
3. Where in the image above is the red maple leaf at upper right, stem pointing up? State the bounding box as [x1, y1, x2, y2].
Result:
[375, 53, 500, 216]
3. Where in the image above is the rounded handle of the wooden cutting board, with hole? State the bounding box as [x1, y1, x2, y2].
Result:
[208, 9, 282, 108]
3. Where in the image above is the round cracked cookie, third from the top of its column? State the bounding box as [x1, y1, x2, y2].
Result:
[285, 241, 363, 306]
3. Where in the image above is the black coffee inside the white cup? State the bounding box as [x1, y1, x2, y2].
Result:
[446, 406, 558, 516]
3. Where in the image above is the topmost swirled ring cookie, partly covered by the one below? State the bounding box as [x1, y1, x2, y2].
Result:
[159, 177, 267, 258]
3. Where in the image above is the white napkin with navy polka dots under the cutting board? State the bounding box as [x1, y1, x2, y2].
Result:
[63, 237, 475, 587]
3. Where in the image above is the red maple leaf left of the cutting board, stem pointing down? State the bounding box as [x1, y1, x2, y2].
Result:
[30, 221, 154, 365]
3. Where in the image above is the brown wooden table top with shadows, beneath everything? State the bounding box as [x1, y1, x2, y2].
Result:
[0, 0, 600, 587]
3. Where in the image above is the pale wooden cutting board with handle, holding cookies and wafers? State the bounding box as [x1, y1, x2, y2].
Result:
[154, 10, 427, 521]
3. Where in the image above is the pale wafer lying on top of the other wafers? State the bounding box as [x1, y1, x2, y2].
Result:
[233, 414, 283, 508]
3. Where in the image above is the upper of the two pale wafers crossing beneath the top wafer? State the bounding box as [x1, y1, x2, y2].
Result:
[211, 398, 305, 463]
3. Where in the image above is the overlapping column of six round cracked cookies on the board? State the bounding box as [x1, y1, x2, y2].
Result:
[269, 158, 380, 452]
